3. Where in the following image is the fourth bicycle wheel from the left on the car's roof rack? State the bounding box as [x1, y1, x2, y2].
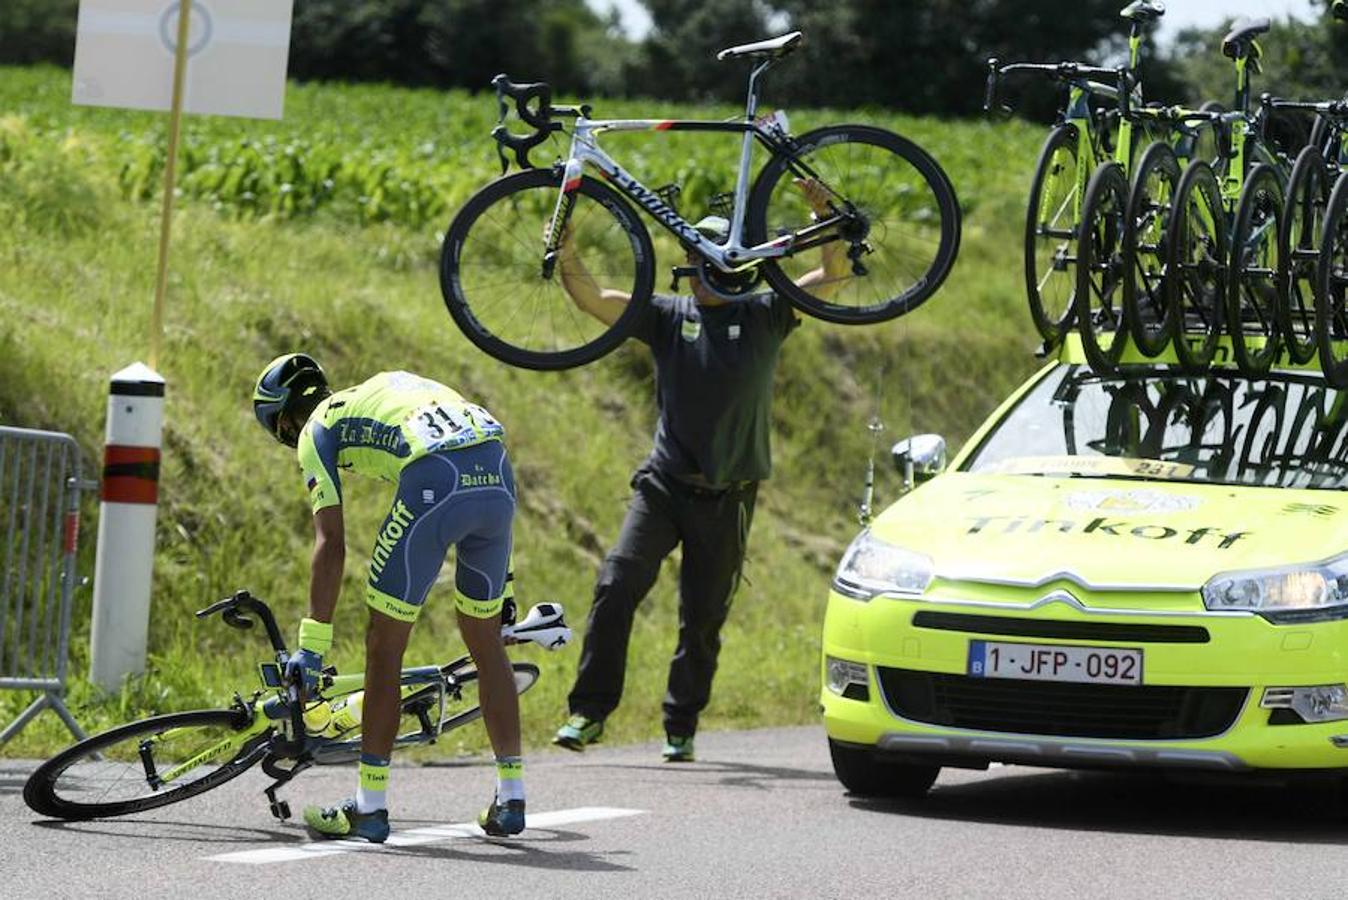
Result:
[1165, 160, 1229, 373]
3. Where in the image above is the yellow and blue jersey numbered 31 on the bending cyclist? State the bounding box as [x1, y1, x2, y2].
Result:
[297, 372, 506, 512]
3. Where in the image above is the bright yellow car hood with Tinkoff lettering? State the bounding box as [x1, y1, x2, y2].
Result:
[872, 472, 1348, 590]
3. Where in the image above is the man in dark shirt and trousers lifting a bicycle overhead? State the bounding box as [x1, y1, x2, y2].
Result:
[553, 181, 851, 763]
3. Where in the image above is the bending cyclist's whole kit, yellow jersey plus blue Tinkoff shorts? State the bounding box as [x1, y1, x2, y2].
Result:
[298, 372, 515, 622]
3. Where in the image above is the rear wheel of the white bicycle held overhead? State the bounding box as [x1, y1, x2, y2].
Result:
[745, 125, 960, 325]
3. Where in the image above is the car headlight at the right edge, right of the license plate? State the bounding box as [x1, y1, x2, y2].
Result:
[1202, 555, 1348, 622]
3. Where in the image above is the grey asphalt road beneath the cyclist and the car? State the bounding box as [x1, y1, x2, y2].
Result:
[0, 728, 1348, 900]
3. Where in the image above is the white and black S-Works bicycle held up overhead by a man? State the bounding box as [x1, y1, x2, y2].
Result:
[441, 31, 960, 369]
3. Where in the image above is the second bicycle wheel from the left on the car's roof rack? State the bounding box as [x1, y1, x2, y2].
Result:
[1076, 163, 1130, 373]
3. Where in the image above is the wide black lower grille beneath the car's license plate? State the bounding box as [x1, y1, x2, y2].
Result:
[878, 666, 1248, 740]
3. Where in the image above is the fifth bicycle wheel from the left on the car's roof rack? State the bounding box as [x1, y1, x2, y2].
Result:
[1227, 164, 1285, 377]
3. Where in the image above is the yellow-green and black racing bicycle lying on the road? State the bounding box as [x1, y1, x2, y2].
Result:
[23, 590, 572, 821]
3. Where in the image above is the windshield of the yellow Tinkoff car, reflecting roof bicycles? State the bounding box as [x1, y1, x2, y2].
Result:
[964, 365, 1348, 490]
